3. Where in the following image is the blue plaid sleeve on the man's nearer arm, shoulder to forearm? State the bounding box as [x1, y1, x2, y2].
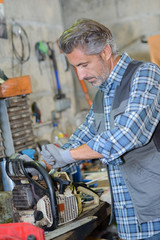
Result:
[88, 63, 160, 163]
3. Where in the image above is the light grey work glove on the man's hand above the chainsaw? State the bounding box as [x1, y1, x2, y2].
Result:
[41, 144, 75, 168]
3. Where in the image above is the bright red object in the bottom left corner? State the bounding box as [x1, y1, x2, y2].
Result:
[0, 223, 45, 240]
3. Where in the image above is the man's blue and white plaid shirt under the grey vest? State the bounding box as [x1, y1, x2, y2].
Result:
[63, 53, 160, 240]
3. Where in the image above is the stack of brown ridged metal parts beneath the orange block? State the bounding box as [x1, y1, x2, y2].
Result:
[5, 96, 36, 151]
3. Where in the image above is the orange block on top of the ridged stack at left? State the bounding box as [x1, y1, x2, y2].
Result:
[0, 75, 32, 98]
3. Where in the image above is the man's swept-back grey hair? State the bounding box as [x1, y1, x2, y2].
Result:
[58, 19, 118, 56]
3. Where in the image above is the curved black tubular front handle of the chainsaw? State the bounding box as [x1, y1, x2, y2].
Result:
[21, 161, 58, 231]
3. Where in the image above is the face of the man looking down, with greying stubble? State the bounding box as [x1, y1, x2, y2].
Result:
[66, 48, 110, 87]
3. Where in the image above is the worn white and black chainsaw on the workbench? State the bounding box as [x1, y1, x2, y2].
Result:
[6, 159, 79, 231]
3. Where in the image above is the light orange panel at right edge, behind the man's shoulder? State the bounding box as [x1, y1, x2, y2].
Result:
[148, 34, 160, 67]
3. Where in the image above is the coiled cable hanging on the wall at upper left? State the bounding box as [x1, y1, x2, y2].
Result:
[11, 23, 31, 76]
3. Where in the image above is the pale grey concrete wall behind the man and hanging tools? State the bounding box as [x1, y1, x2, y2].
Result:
[0, 0, 160, 146]
